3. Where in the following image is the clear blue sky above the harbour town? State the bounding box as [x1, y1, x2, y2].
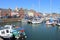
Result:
[0, 0, 60, 13]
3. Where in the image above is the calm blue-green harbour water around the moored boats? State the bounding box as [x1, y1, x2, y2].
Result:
[1, 22, 60, 40]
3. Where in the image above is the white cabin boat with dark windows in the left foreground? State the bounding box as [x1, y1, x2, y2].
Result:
[0, 25, 12, 38]
